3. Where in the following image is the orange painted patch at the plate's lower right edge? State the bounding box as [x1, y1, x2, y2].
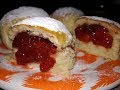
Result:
[92, 60, 120, 90]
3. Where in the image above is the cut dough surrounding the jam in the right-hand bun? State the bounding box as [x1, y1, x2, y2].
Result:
[75, 17, 120, 60]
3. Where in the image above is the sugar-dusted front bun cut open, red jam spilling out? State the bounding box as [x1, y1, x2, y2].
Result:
[4, 17, 75, 76]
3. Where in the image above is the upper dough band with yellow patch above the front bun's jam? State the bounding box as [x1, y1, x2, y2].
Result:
[8, 24, 71, 48]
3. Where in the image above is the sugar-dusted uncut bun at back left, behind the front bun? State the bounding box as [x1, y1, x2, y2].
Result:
[0, 6, 49, 49]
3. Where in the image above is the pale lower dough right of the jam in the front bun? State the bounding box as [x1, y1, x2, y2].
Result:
[50, 47, 75, 77]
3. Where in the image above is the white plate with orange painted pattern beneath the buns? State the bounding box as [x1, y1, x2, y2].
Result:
[0, 40, 120, 90]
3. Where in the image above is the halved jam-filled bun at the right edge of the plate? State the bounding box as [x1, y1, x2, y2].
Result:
[74, 16, 120, 60]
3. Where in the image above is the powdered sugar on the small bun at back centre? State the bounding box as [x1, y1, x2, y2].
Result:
[53, 7, 84, 17]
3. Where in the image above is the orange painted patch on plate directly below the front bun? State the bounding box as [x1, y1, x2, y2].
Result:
[24, 73, 82, 90]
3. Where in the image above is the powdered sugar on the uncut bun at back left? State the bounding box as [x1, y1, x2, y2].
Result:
[1, 6, 49, 23]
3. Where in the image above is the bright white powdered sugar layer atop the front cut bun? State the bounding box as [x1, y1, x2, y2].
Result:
[13, 17, 72, 40]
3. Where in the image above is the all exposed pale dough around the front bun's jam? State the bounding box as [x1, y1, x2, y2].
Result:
[9, 24, 75, 76]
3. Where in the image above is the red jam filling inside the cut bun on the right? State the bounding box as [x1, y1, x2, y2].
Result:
[75, 24, 113, 48]
